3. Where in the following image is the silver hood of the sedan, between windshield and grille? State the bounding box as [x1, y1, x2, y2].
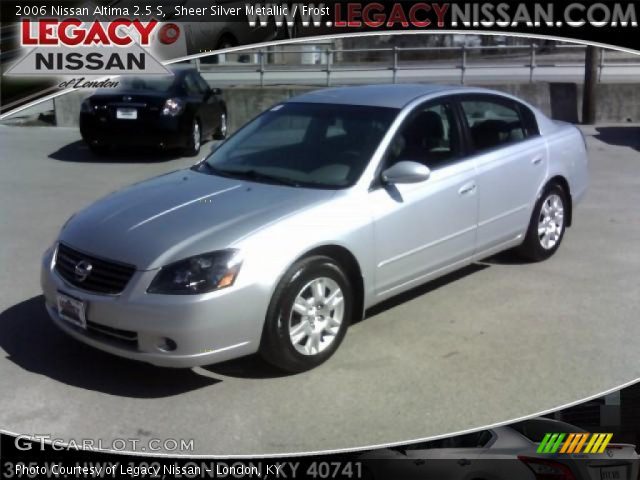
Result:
[60, 170, 335, 270]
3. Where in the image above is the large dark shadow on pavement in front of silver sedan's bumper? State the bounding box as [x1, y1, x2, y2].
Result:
[0, 295, 220, 398]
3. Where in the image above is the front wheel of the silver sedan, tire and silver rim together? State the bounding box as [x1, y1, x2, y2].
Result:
[260, 256, 353, 373]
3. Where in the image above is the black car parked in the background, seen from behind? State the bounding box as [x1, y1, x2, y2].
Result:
[80, 66, 227, 155]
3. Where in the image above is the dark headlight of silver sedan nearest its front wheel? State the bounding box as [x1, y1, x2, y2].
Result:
[147, 249, 242, 295]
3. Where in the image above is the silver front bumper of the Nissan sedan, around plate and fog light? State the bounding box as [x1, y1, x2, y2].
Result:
[41, 249, 268, 368]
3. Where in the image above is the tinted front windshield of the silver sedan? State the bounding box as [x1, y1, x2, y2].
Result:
[198, 103, 398, 189]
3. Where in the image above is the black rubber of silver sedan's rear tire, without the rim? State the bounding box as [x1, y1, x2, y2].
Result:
[515, 184, 568, 262]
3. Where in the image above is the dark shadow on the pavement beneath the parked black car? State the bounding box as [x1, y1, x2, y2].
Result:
[49, 140, 188, 163]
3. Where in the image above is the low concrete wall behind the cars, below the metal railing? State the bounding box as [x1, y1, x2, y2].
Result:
[54, 83, 640, 131]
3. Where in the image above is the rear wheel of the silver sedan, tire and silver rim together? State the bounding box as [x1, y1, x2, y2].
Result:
[516, 185, 567, 262]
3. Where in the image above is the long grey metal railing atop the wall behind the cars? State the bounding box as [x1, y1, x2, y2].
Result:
[197, 43, 640, 86]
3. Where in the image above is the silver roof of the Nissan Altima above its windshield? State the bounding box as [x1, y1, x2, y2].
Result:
[288, 84, 464, 108]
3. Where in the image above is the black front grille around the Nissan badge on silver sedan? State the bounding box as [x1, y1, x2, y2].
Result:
[55, 243, 136, 295]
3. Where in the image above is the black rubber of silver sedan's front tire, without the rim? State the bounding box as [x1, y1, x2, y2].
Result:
[260, 256, 354, 373]
